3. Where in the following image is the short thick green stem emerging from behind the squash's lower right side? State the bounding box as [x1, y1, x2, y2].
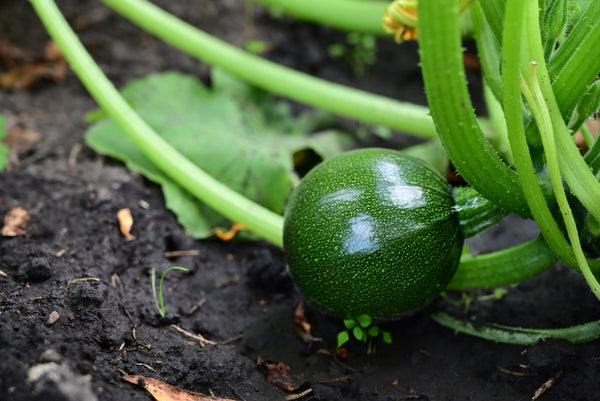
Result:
[446, 237, 558, 291]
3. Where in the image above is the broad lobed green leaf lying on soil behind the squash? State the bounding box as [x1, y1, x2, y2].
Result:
[86, 70, 350, 238]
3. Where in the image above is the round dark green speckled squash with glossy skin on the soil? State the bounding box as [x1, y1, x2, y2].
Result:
[283, 149, 463, 319]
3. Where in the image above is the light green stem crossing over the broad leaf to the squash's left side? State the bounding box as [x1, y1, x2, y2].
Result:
[31, 0, 283, 246]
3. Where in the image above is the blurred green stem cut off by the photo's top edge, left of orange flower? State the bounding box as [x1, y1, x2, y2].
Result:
[246, 0, 390, 36]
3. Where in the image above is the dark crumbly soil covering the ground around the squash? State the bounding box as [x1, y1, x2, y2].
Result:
[0, 0, 600, 401]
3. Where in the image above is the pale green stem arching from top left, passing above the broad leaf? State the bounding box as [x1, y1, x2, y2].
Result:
[97, 0, 436, 139]
